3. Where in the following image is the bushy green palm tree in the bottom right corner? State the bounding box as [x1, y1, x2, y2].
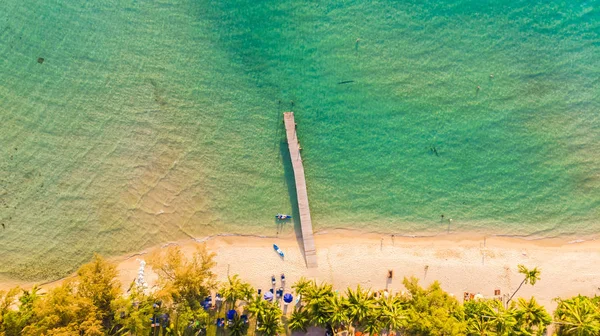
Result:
[554, 295, 600, 336]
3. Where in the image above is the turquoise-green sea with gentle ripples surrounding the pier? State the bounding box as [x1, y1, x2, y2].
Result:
[0, 0, 600, 280]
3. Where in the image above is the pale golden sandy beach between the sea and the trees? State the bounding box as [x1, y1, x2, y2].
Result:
[2, 230, 600, 310]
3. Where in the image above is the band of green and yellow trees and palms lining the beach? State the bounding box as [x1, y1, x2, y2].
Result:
[0, 256, 600, 336]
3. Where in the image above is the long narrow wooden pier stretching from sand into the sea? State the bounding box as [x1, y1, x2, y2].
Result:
[283, 112, 317, 268]
